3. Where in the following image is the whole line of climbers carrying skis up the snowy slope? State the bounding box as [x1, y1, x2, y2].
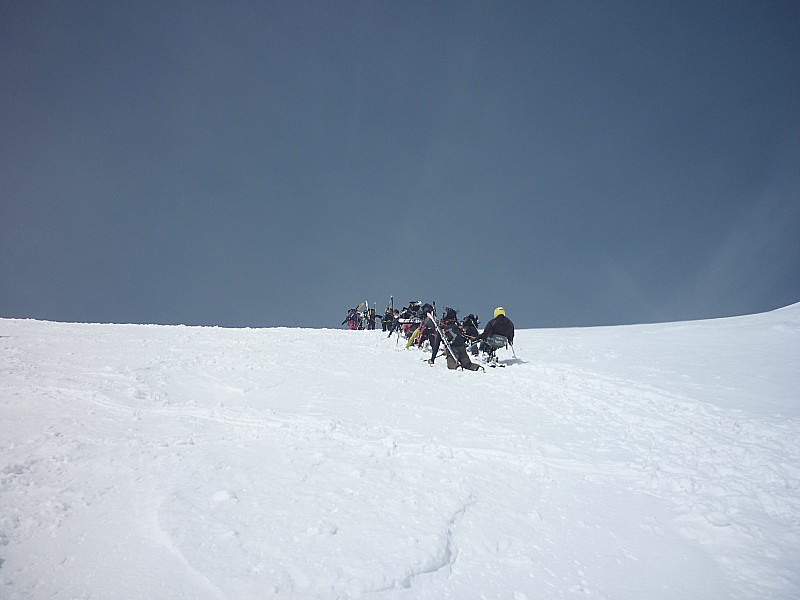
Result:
[342, 301, 514, 371]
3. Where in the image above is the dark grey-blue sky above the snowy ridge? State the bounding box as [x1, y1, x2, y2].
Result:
[0, 1, 800, 327]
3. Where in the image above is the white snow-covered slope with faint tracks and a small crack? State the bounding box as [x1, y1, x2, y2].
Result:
[0, 305, 800, 600]
